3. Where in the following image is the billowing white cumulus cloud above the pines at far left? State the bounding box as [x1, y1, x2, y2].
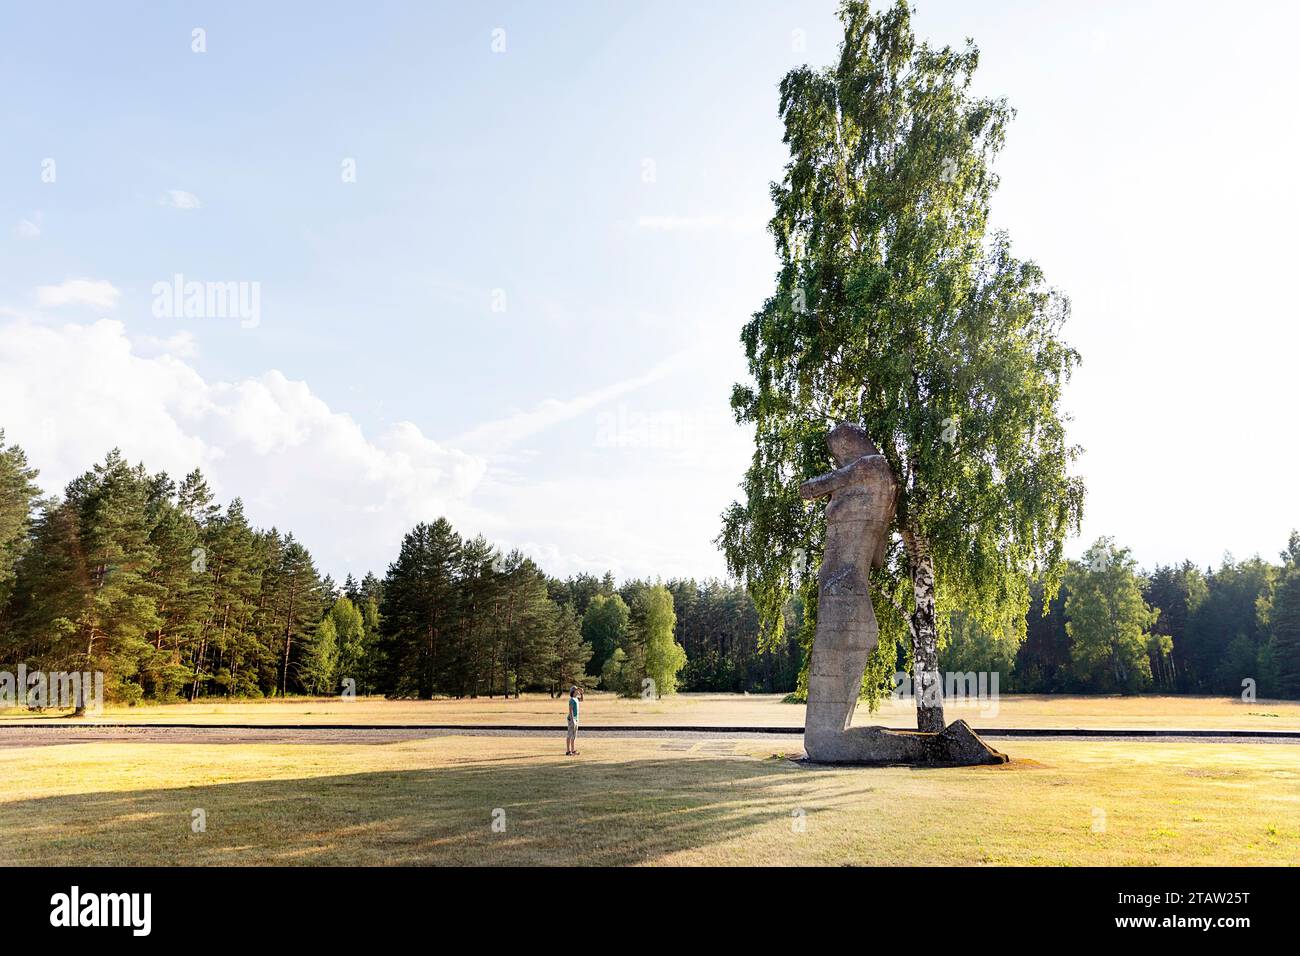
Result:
[0, 319, 486, 574]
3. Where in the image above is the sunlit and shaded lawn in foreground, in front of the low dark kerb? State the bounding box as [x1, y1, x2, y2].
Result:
[0, 735, 1300, 865]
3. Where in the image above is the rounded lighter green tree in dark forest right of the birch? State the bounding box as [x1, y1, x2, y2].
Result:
[1065, 538, 1160, 693]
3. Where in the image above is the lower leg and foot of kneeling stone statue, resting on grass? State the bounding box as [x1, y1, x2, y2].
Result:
[803, 721, 1010, 767]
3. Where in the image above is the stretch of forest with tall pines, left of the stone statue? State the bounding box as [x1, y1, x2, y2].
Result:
[0, 431, 798, 702]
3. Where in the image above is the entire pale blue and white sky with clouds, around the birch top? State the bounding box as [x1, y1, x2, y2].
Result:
[0, 0, 1300, 579]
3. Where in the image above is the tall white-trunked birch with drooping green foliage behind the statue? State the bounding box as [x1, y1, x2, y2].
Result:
[719, 0, 1083, 731]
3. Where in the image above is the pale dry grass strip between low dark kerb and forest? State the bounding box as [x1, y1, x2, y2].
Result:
[0, 693, 1300, 730]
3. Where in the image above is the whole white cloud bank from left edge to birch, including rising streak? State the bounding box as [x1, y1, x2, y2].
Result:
[0, 308, 748, 576]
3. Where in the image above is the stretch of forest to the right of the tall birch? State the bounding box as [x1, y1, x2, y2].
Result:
[943, 531, 1300, 698]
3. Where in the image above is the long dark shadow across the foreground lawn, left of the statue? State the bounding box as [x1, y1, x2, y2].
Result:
[0, 758, 871, 866]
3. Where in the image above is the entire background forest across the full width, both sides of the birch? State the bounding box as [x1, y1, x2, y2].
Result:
[0, 432, 1300, 702]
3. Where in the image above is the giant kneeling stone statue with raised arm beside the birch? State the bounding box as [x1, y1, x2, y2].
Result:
[800, 423, 1006, 765]
